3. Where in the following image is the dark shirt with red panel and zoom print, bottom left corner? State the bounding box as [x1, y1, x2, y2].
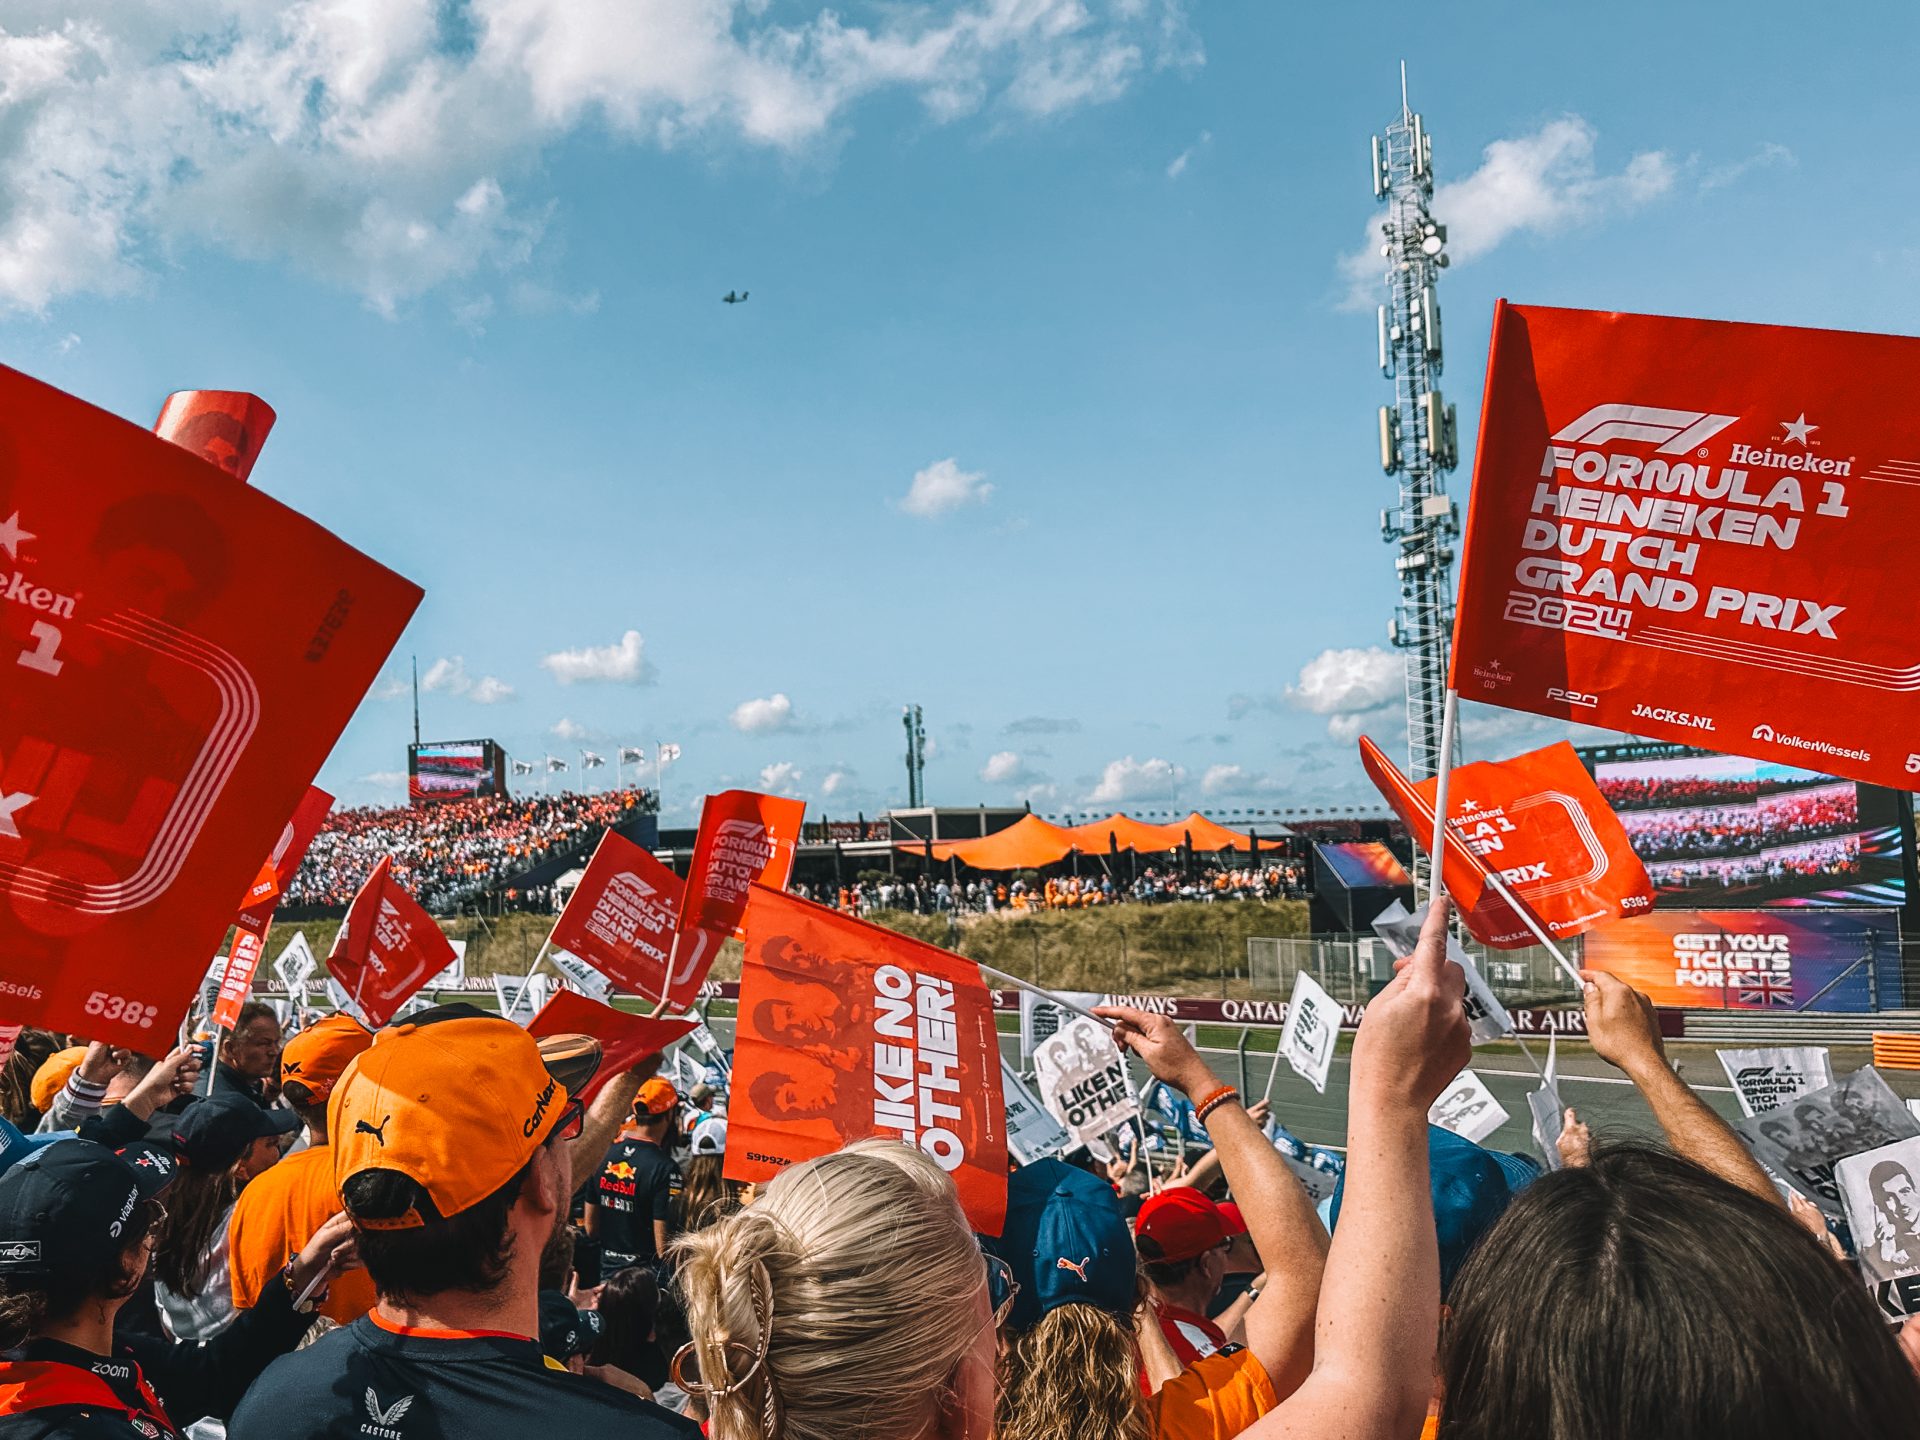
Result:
[0, 1279, 313, 1440]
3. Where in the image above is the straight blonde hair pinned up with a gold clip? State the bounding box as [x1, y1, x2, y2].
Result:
[674, 1140, 987, 1440]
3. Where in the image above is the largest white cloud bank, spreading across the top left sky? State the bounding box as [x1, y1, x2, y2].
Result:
[0, 0, 1200, 323]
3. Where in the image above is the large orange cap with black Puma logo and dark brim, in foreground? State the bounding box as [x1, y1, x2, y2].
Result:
[326, 1016, 568, 1231]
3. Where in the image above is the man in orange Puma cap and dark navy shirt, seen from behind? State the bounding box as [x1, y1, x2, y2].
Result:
[227, 1006, 699, 1440]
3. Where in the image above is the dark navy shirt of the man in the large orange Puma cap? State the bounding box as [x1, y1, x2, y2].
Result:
[227, 1315, 701, 1440]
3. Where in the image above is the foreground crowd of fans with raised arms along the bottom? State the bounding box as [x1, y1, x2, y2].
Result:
[0, 908, 1920, 1440]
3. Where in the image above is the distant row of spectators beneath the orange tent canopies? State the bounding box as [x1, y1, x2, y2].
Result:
[793, 864, 1306, 916]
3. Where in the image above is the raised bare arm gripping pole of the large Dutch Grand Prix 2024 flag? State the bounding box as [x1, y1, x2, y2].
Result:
[1244, 900, 1473, 1440]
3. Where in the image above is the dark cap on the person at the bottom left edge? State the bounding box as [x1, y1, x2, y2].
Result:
[0, 1140, 175, 1277]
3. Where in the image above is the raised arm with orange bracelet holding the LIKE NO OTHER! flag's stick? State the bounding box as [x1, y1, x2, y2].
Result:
[1094, 1006, 1327, 1396]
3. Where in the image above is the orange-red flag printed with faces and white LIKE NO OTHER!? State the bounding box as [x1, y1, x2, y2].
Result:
[726, 885, 1006, 1235]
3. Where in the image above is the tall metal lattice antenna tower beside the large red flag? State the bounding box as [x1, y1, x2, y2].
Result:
[1373, 63, 1459, 821]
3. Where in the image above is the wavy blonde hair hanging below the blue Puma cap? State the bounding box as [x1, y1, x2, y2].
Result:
[993, 1282, 1148, 1440]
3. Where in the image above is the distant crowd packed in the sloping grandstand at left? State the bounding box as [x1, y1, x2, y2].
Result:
[284, 789, 649, 912]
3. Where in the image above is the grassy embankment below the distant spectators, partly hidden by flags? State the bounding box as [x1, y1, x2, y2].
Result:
[267, 900, 1308, 995]
